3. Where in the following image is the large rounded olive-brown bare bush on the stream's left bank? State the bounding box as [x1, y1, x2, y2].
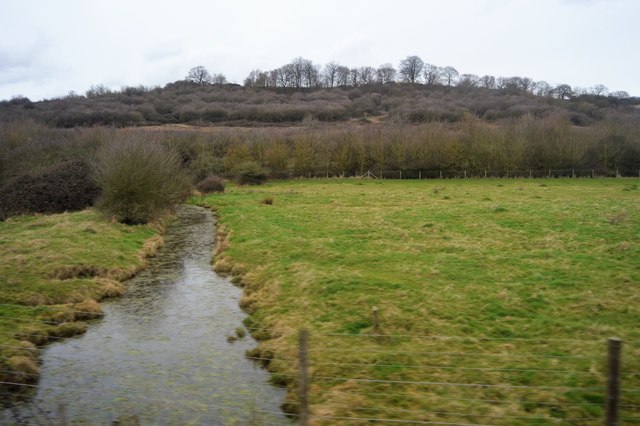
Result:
[94, 138, 190, 224]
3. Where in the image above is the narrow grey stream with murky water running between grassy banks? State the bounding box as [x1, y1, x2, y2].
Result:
[3, 206, 290, 425]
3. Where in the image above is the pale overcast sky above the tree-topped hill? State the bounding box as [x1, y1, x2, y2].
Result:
[0, 0, 640, 100]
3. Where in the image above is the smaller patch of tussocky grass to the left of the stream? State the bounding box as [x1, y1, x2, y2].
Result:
[0, 210, 162, 382]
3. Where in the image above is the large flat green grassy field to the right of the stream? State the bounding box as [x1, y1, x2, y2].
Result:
[204, 179, 640, 424]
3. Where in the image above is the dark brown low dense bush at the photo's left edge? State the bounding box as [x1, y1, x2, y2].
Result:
[0, 161, 100, 220]
